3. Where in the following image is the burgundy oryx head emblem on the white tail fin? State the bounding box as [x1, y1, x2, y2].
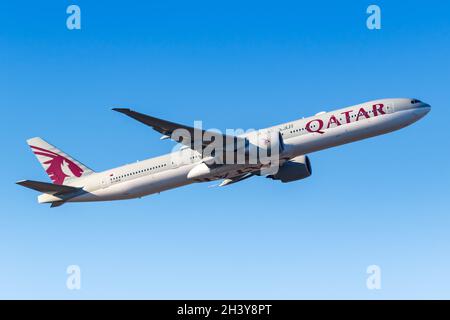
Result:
[30, 146, 83, 184]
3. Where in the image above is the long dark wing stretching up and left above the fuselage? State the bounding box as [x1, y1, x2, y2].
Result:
[113, 108, 246, 151]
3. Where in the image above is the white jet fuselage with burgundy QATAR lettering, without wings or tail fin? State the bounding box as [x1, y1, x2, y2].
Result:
[39, 99, 430, 202]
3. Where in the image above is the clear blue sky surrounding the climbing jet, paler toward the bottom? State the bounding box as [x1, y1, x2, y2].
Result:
[0, 0, 450, 299]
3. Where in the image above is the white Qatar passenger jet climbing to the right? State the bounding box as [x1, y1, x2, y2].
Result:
[17, 98, 431, 207]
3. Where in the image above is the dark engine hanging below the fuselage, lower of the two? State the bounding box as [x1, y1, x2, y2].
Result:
[267, 156, 312, 183]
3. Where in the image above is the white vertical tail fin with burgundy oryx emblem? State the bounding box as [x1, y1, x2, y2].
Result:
[27, 137, 94, 185]
